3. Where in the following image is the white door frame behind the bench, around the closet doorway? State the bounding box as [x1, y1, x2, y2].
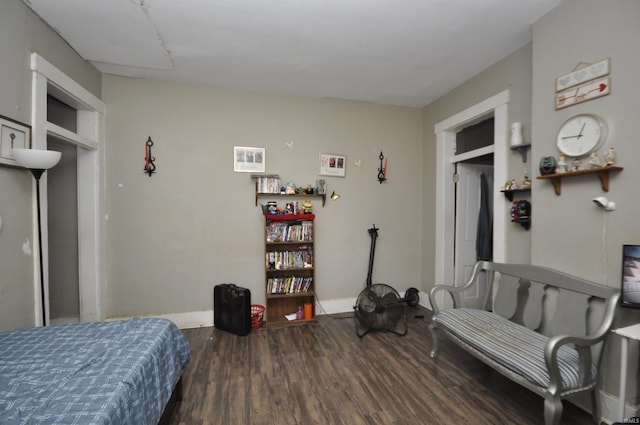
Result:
[434, 90, 509, 301]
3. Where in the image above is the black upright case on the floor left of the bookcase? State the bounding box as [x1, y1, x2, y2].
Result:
[213, 283, 251, 336]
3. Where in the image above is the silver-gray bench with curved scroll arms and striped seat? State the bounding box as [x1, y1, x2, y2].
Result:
[429, 261, 620, 425]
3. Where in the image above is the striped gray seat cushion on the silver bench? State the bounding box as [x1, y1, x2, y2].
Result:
[433, 308, 597, 390]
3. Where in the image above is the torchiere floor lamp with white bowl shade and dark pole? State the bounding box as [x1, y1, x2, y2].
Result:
[11, 149, 62, 326]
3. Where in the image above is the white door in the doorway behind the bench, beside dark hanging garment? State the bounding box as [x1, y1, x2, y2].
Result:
[454, 162, 493, 308]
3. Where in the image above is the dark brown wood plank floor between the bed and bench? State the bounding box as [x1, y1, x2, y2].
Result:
[170, 308, 592, 425]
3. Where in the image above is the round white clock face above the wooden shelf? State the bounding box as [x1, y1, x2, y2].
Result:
[556, 114, 607, 157]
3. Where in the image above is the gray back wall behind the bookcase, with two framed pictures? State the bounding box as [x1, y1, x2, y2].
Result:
[103, 76, 422, 317]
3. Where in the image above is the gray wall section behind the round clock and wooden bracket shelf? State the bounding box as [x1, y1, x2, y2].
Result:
[531, 0, 640, 408]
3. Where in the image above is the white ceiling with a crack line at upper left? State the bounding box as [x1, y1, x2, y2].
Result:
[24, 0, 562, 107]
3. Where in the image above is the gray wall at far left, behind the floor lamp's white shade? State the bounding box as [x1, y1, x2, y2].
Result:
[0, 0, 101, 331]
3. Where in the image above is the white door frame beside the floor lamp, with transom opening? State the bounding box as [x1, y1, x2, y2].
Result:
[31, 53, 105, 325]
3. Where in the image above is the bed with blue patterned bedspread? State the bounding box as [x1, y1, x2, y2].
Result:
[0, 319, 191, 425]
